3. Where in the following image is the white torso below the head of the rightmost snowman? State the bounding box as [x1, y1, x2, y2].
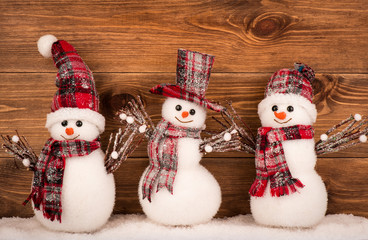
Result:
[250, 139, 327, 227]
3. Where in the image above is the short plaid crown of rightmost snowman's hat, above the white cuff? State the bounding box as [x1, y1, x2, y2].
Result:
[265, 63, 315, 102]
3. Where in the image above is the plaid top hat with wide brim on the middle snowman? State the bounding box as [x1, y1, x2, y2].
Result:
[150, 49, 224, 112]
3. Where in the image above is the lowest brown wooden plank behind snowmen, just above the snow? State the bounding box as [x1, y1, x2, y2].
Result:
[0, 158, 368, 217]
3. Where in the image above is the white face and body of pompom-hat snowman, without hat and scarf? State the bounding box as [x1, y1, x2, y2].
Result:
[34, 119, 115, 232]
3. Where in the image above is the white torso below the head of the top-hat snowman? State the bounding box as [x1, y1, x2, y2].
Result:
[138, 138, 221, 225]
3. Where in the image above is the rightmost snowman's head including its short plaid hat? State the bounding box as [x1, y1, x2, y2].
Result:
[258, 63, 317, 128]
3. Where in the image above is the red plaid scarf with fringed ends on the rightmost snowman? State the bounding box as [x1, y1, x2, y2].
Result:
[249, 125, 314, 197]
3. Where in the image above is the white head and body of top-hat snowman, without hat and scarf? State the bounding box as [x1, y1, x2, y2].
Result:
[138, 98, 221, 225]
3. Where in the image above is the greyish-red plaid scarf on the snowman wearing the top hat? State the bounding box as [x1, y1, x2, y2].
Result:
[142, 119, 201, 202]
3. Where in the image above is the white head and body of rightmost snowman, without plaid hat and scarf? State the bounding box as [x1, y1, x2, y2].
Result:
[250, 94, 327, 227]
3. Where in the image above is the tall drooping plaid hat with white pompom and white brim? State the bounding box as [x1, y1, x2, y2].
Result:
[37, 35, 105, 133]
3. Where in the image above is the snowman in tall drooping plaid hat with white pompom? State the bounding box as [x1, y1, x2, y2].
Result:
[23, 35, 115, 232]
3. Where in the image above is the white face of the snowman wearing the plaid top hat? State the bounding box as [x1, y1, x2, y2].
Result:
[162, 97, 207, 129]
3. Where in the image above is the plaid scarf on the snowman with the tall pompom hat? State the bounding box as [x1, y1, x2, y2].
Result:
[23, 138, 101, 222]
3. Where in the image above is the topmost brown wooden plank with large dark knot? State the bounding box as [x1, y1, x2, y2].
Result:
[0, 0, 368, 73]
